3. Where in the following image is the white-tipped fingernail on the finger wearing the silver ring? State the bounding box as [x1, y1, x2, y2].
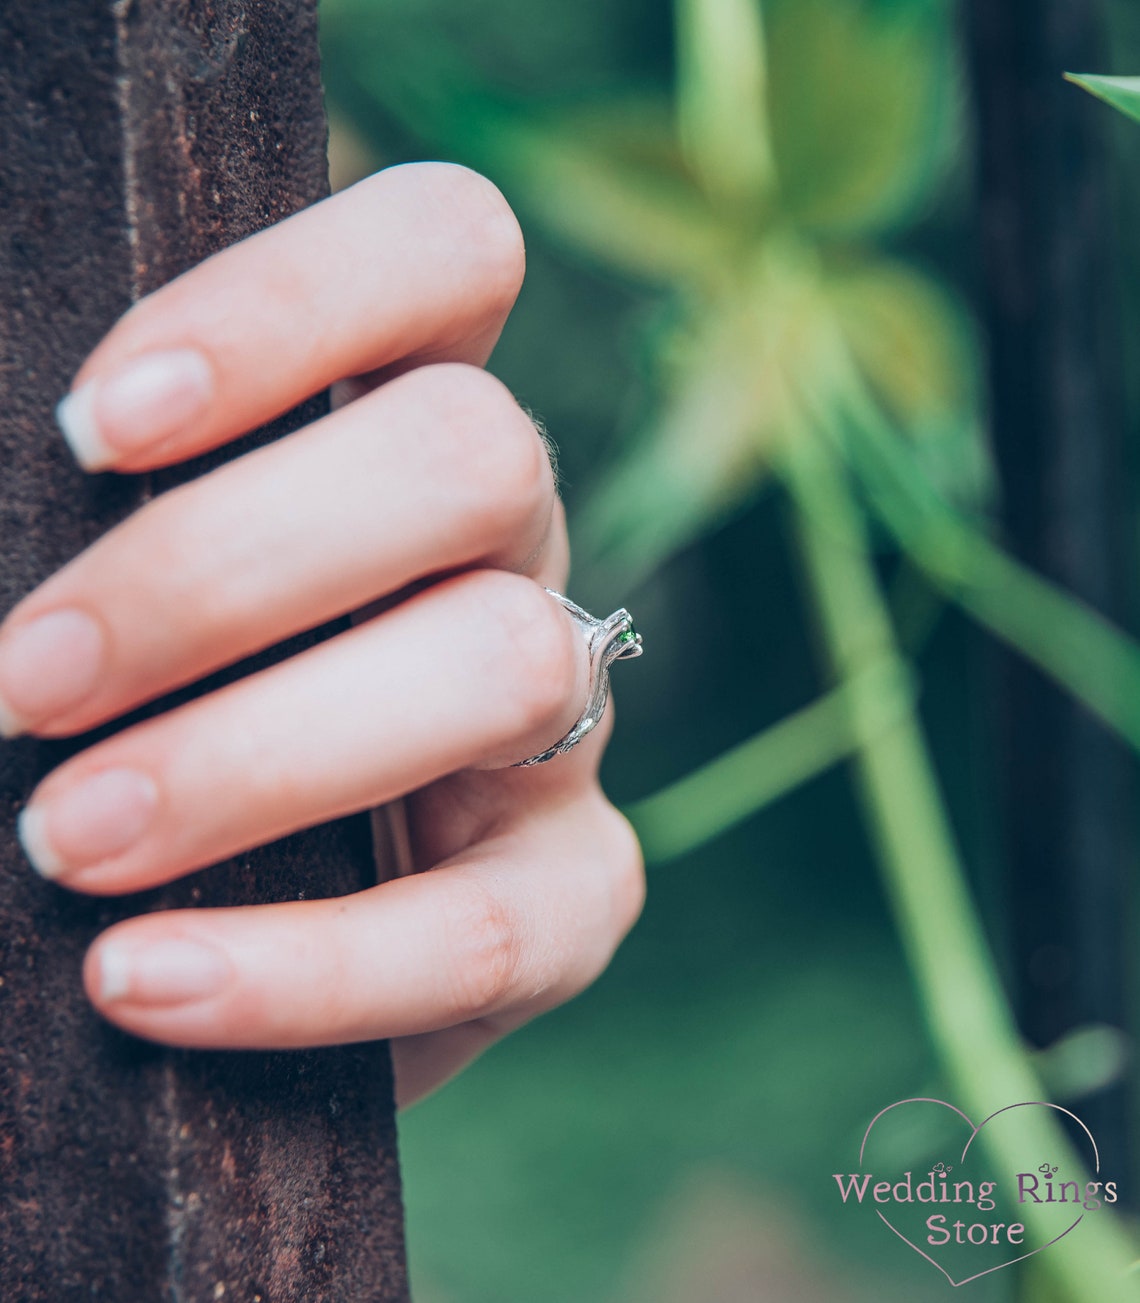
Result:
[17, 769, 158, 878]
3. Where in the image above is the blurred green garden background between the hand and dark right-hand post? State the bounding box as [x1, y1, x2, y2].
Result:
[322, 0, 1140, 1303]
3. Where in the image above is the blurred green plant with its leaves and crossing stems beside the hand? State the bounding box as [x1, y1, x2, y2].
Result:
[319, 0, 1140, 1300]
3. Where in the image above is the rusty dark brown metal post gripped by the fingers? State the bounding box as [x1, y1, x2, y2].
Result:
[0, 0, 406, 1303]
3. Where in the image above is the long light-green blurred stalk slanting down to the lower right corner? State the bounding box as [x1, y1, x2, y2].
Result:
[782, 438, 1137, 1303]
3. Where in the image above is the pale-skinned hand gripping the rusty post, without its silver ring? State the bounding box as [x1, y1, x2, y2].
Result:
[0, 157, 644, 1104]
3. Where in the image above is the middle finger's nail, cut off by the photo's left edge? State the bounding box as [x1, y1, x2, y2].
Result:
[0, 609, 104, 737]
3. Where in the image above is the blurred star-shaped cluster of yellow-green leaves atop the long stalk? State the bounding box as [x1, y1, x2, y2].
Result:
[320, 0, 969, 584]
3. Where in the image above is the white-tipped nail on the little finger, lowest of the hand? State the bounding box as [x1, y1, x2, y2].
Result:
[98, 937, 233, 1005]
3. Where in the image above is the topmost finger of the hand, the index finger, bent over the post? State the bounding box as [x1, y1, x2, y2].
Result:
[59, 163, 524, 470]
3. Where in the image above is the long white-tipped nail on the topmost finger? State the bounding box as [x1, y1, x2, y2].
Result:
[56, 348, 214, 470]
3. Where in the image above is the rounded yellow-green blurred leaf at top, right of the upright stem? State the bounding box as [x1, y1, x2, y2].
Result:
[767, 0, 956, 236]
